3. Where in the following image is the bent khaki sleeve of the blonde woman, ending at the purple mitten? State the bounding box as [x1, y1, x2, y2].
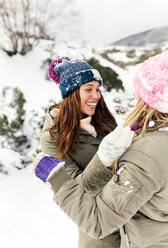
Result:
[49, 148, 163, 239]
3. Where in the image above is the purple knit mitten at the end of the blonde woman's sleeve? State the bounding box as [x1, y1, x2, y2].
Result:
[35, 156, 65, 182]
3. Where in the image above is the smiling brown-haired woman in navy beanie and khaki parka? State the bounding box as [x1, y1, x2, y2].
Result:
[40, 59, 120, 248]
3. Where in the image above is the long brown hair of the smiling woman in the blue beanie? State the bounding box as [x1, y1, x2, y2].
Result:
[50, 88, 117, 158]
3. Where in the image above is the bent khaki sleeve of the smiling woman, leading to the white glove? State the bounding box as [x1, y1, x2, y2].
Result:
[40, 113, 112, 196]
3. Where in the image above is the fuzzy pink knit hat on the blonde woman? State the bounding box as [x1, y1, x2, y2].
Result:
[133, 51, 168, 113]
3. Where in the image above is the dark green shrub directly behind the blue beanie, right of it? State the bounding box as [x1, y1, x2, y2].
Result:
[87, 58, 124, 91]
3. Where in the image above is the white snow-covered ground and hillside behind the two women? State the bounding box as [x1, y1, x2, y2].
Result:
[0, 40, 167, 248]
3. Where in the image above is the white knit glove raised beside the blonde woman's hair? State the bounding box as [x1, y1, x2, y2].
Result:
[98, 126, 135, 167]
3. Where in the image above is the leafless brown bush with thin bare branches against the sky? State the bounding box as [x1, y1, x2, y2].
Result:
[0, 0, 80, 54]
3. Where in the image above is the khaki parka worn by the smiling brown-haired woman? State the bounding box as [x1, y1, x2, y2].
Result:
[40, 111, 120, 248]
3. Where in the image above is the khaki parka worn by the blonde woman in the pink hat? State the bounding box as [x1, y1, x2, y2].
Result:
[49, 129, 168, 248]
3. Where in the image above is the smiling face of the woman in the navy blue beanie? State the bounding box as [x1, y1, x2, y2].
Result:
[79, 81, 101, 116]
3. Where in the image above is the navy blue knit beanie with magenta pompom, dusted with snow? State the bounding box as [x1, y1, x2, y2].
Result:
[48, 59, 103, 98]
